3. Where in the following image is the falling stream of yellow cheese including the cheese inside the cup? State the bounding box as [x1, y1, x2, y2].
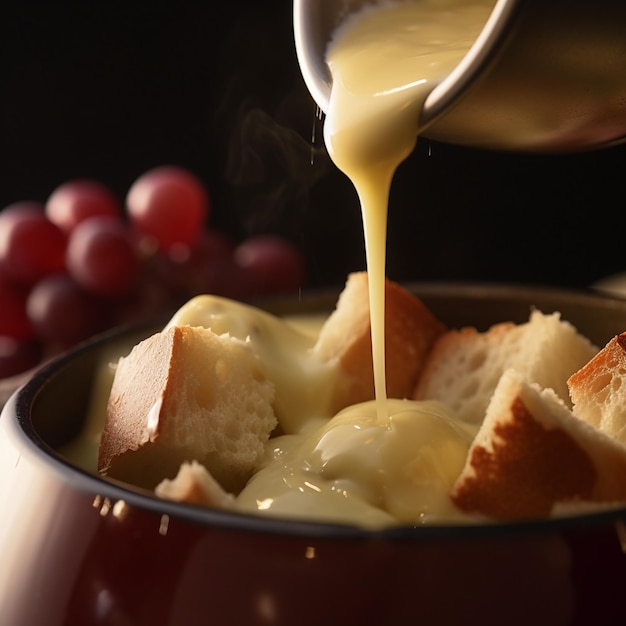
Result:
[324, 0, 494, 424]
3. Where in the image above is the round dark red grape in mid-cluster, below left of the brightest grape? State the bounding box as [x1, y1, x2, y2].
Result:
[67, 217, 139, 297]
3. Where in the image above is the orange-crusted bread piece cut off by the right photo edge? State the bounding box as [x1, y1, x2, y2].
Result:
[567, 332, 626, 444]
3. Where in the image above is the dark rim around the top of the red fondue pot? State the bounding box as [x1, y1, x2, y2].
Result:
[7, 282, 626, 541]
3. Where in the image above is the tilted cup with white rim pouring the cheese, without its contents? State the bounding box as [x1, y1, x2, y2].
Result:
[293, 0, 626, 153]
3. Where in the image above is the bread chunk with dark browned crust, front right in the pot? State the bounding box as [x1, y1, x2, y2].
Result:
[452, 369, 626, 520]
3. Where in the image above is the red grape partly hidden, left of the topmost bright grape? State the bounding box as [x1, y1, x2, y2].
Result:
[46, 179, 122, 234]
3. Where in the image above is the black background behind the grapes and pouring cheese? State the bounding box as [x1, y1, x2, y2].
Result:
[0, 0, 626, 286]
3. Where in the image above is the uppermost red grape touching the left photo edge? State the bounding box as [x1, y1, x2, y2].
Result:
[0, 202, 66, 286]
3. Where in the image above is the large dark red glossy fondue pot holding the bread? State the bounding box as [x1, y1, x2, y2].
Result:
[0, 284, 626, 626]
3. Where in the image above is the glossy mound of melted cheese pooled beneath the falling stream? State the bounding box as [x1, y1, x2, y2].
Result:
[237, 400, 475, 528]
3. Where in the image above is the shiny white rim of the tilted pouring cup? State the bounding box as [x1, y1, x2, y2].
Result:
[293, 0, 519, 123]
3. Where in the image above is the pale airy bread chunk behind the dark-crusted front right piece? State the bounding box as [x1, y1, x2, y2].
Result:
[413, 310, 597, 424]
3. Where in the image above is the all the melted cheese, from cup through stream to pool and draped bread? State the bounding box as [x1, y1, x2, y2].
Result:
[72, 0, 494, 527]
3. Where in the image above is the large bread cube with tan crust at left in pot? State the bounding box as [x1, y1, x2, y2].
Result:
[98, 326, 277, 493]
